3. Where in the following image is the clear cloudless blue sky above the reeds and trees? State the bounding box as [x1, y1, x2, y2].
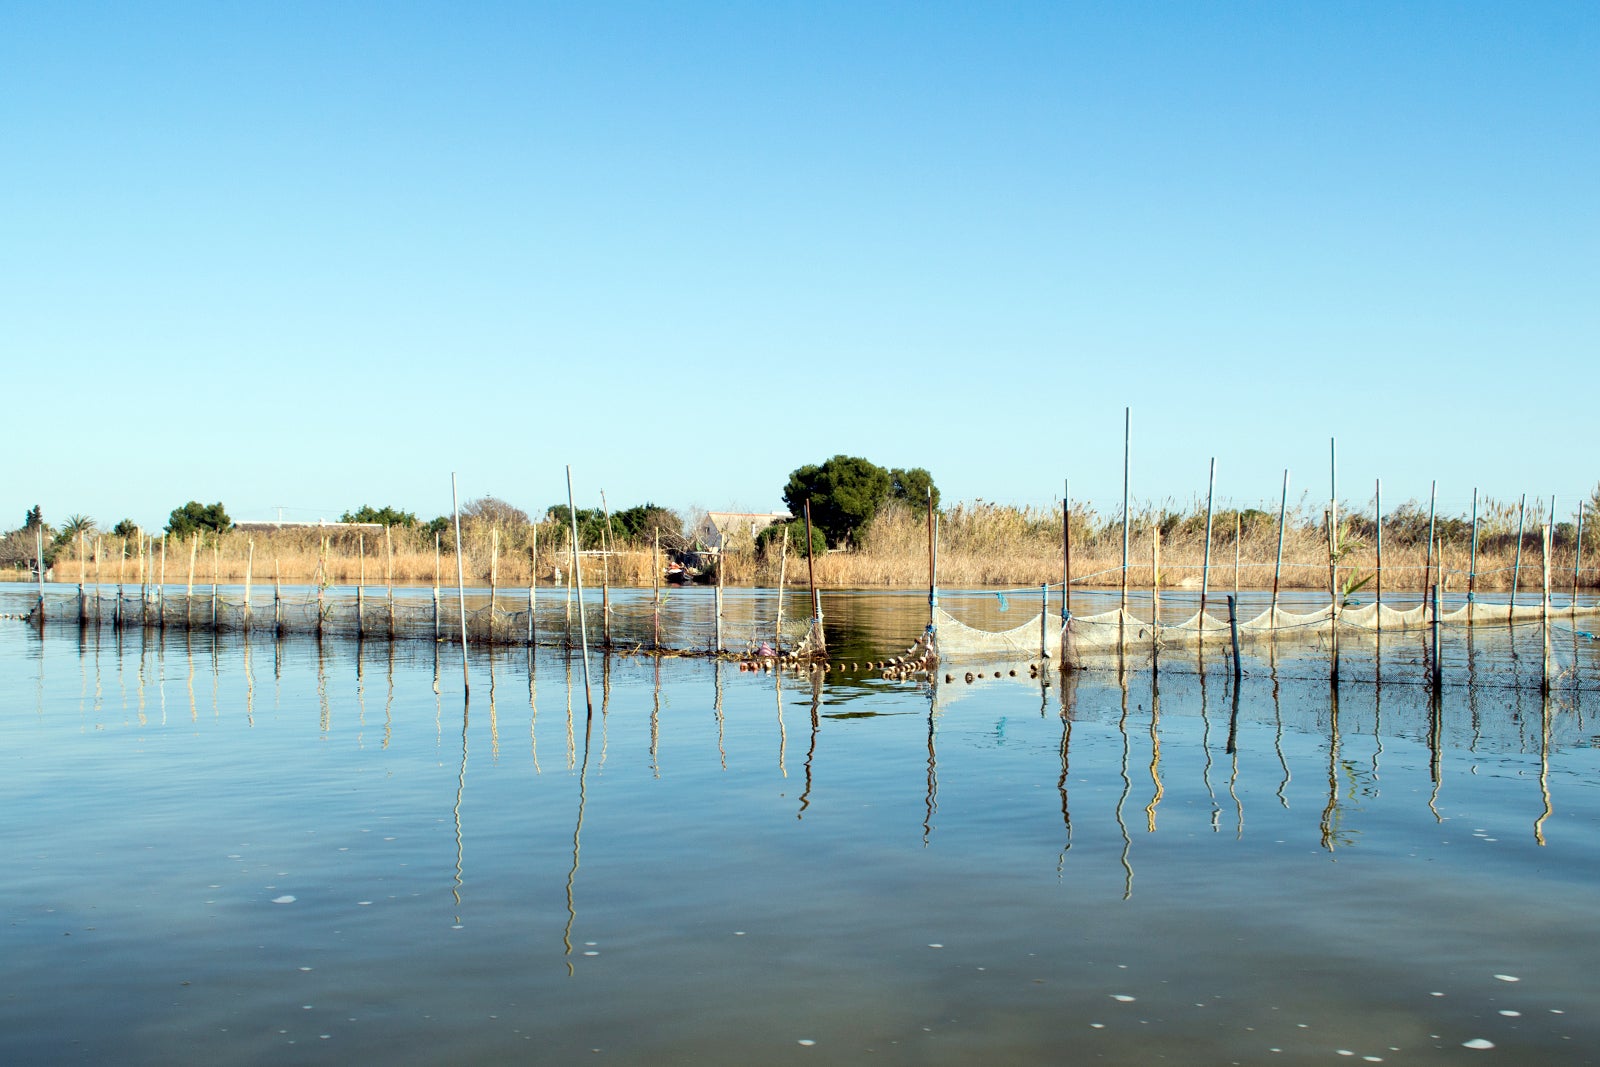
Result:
[0, 0, 1600, 528]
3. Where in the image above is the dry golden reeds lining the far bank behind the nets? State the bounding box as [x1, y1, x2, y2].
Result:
[18, 502, 1600, 597]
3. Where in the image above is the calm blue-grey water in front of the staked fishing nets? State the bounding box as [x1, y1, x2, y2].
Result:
[0, 593, 1600, 1064]
